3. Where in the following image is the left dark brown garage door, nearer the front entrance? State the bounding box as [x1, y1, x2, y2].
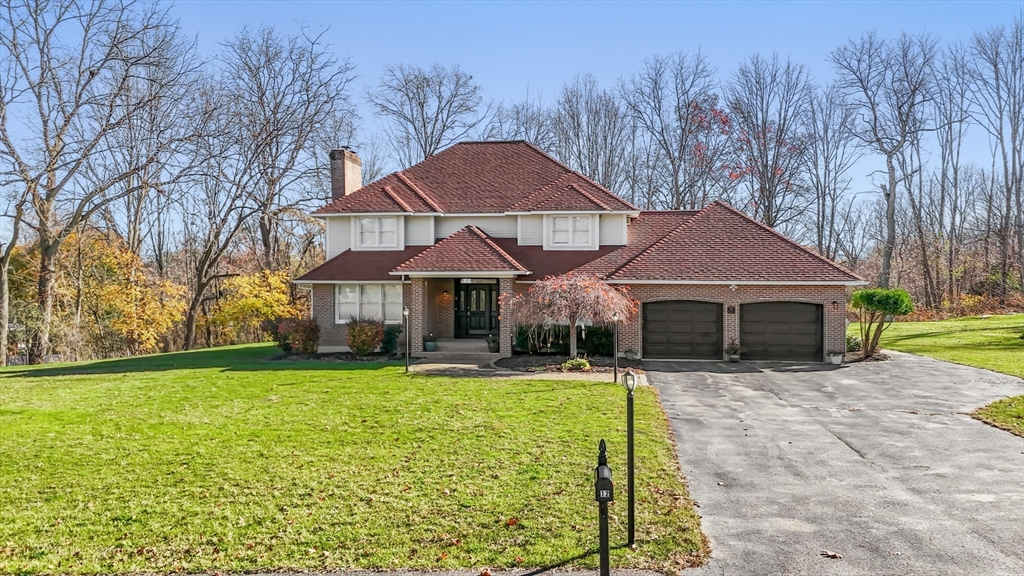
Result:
[643, 300, 722, 360]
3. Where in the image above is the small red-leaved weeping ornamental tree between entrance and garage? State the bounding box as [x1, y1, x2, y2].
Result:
[502, 273, 639, 358]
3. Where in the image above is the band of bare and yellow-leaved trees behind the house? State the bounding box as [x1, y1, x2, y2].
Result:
[0, 0, 1024, 363]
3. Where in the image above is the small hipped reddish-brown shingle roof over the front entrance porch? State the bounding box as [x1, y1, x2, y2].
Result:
[394, 225, 528, 274]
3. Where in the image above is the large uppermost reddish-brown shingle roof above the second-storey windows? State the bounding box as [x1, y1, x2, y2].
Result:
[313, 141, 636, 214]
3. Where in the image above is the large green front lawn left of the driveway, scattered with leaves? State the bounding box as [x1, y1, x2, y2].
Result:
[0, 345, 707, 574]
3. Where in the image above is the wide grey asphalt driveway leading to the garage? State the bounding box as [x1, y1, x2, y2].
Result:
[647, 353, 1024, 575]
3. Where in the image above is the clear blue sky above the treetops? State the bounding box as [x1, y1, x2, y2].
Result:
[172, 0, 1024, 100]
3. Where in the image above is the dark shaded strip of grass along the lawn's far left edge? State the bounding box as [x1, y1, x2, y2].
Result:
[0, 346, 400, 378]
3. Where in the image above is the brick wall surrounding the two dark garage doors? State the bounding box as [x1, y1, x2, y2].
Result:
[618, 284, 848, 361]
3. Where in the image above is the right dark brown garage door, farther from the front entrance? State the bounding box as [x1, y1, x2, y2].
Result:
[739, 302, 823, 362]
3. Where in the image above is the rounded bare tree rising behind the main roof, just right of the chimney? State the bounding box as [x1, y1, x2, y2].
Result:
[367, 64, 488, 168]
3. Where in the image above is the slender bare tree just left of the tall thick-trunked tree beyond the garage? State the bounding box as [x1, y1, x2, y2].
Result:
[804, 84, 860, 259]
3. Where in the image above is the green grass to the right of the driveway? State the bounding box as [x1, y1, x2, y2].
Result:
[850, 314, 1024, 436]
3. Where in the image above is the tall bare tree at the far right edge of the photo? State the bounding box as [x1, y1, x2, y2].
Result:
[970, 16, 1024, 294]
